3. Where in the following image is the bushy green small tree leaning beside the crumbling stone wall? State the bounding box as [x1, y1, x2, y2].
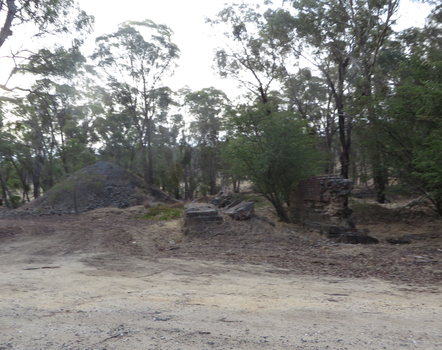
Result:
[225, 105, 319, 221]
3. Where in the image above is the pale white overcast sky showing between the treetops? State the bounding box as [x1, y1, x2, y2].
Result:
[0, 0, 436, 98]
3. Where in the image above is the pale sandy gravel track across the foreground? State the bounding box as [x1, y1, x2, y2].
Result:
[0, 209, 442, 349]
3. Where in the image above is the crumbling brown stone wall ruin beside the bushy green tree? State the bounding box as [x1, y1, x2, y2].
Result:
[290, 175, 378, 243]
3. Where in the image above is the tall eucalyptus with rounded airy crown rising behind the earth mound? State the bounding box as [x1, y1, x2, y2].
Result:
[92, 20, 179, 184]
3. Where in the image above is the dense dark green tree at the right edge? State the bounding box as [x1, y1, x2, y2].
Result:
[376, 5, 442, 215]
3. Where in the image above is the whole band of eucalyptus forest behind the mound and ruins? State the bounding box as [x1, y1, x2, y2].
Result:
[0, 0, 442, 221]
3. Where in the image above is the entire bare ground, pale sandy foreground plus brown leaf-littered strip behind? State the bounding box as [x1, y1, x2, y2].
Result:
[0, 207, 442, 350]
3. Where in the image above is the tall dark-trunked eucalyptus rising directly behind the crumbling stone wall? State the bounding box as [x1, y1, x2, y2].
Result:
[291, 0, 399, 201]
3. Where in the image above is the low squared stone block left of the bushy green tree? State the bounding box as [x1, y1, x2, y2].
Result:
[183, 203, 223, 233]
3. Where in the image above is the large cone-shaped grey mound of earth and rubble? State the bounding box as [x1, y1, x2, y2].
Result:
[16, 162, 175, 215]
